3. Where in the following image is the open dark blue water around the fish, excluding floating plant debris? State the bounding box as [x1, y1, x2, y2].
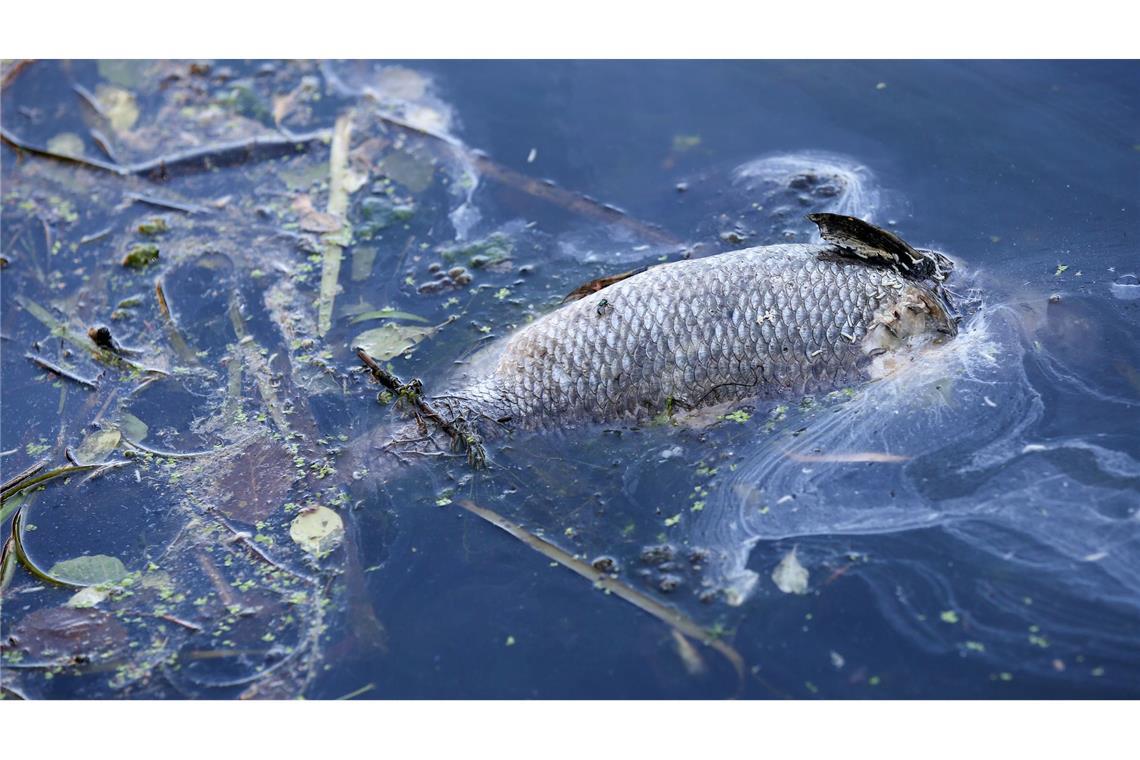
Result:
[0, 62, 1140, 698]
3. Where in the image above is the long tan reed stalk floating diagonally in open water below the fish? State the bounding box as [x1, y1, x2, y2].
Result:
[456, 499, 744, 689]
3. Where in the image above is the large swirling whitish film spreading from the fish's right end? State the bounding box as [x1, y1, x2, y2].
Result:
[674, 293, 1140, 683]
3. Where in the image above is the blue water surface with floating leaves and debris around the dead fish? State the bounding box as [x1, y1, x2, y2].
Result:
[0, 62, 1140, 698]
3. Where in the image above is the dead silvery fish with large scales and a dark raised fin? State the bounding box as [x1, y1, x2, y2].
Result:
[424, 214, 958, 431]
